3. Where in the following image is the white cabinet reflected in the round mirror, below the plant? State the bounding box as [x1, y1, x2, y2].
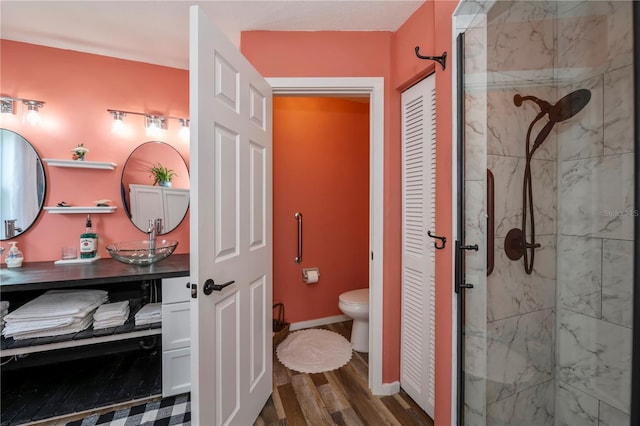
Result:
[129, 184, 189, 232]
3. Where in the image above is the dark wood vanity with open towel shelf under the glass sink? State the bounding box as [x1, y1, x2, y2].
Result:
[0, 254, 189, 425]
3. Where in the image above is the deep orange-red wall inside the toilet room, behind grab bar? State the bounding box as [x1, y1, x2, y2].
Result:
[273, 96, 369, 322]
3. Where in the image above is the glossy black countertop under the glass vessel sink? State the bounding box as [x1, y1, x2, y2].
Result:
[0, 254, 189, 292]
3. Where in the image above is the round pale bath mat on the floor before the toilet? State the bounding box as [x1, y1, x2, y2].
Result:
[276, 328, 351, 373]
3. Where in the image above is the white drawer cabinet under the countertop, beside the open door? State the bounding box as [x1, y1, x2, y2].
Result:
[162, 277, 191, 397]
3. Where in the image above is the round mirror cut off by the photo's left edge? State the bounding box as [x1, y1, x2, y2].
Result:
[0, 129, 47, 241]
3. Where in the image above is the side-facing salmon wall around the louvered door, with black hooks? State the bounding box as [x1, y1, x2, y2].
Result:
[393, 0, 458, 426]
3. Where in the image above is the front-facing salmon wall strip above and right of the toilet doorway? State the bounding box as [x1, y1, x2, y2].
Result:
[240, 31, 401, 383]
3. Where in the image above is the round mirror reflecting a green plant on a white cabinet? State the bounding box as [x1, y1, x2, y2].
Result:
[120, 141, 189, 234]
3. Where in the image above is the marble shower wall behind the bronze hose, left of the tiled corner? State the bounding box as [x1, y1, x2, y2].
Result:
[486, 2, 557, 425]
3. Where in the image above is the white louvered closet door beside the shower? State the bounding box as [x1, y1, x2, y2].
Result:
[400, 74, 436, 418]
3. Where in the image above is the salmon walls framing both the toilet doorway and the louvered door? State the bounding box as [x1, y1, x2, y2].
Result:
[241, 0, 458, 425]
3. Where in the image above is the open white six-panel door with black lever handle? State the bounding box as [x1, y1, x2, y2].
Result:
[189, 6, 272, 426]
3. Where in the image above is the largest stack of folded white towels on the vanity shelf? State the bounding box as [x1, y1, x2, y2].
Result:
[2, 290, 109, 340]
